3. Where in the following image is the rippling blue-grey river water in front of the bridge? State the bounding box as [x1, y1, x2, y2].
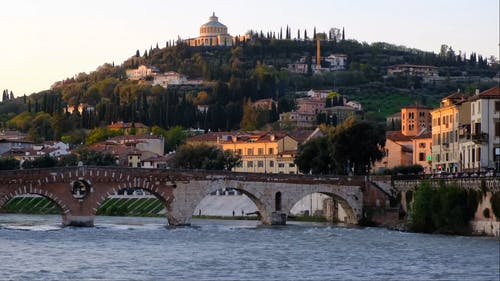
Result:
[0, 214, 500, 280]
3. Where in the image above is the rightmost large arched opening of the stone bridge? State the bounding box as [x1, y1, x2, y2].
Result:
[290, 192, 354, 223]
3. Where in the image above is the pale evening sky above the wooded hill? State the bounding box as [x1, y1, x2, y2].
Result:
[0, 0, 500, 96]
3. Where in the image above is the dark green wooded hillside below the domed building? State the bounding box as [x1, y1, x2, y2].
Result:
[0, 36, 498, 142]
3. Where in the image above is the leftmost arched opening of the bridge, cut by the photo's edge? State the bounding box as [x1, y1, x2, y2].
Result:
[0, 192, 67, 230]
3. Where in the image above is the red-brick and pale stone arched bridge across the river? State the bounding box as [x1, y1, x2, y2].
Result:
[0, 166, 366, 226]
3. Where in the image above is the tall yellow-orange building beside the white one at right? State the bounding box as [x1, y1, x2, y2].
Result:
[431, 93, 466, 172]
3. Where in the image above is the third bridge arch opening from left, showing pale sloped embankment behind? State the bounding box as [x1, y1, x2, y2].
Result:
[193, 187, 260, 220]
